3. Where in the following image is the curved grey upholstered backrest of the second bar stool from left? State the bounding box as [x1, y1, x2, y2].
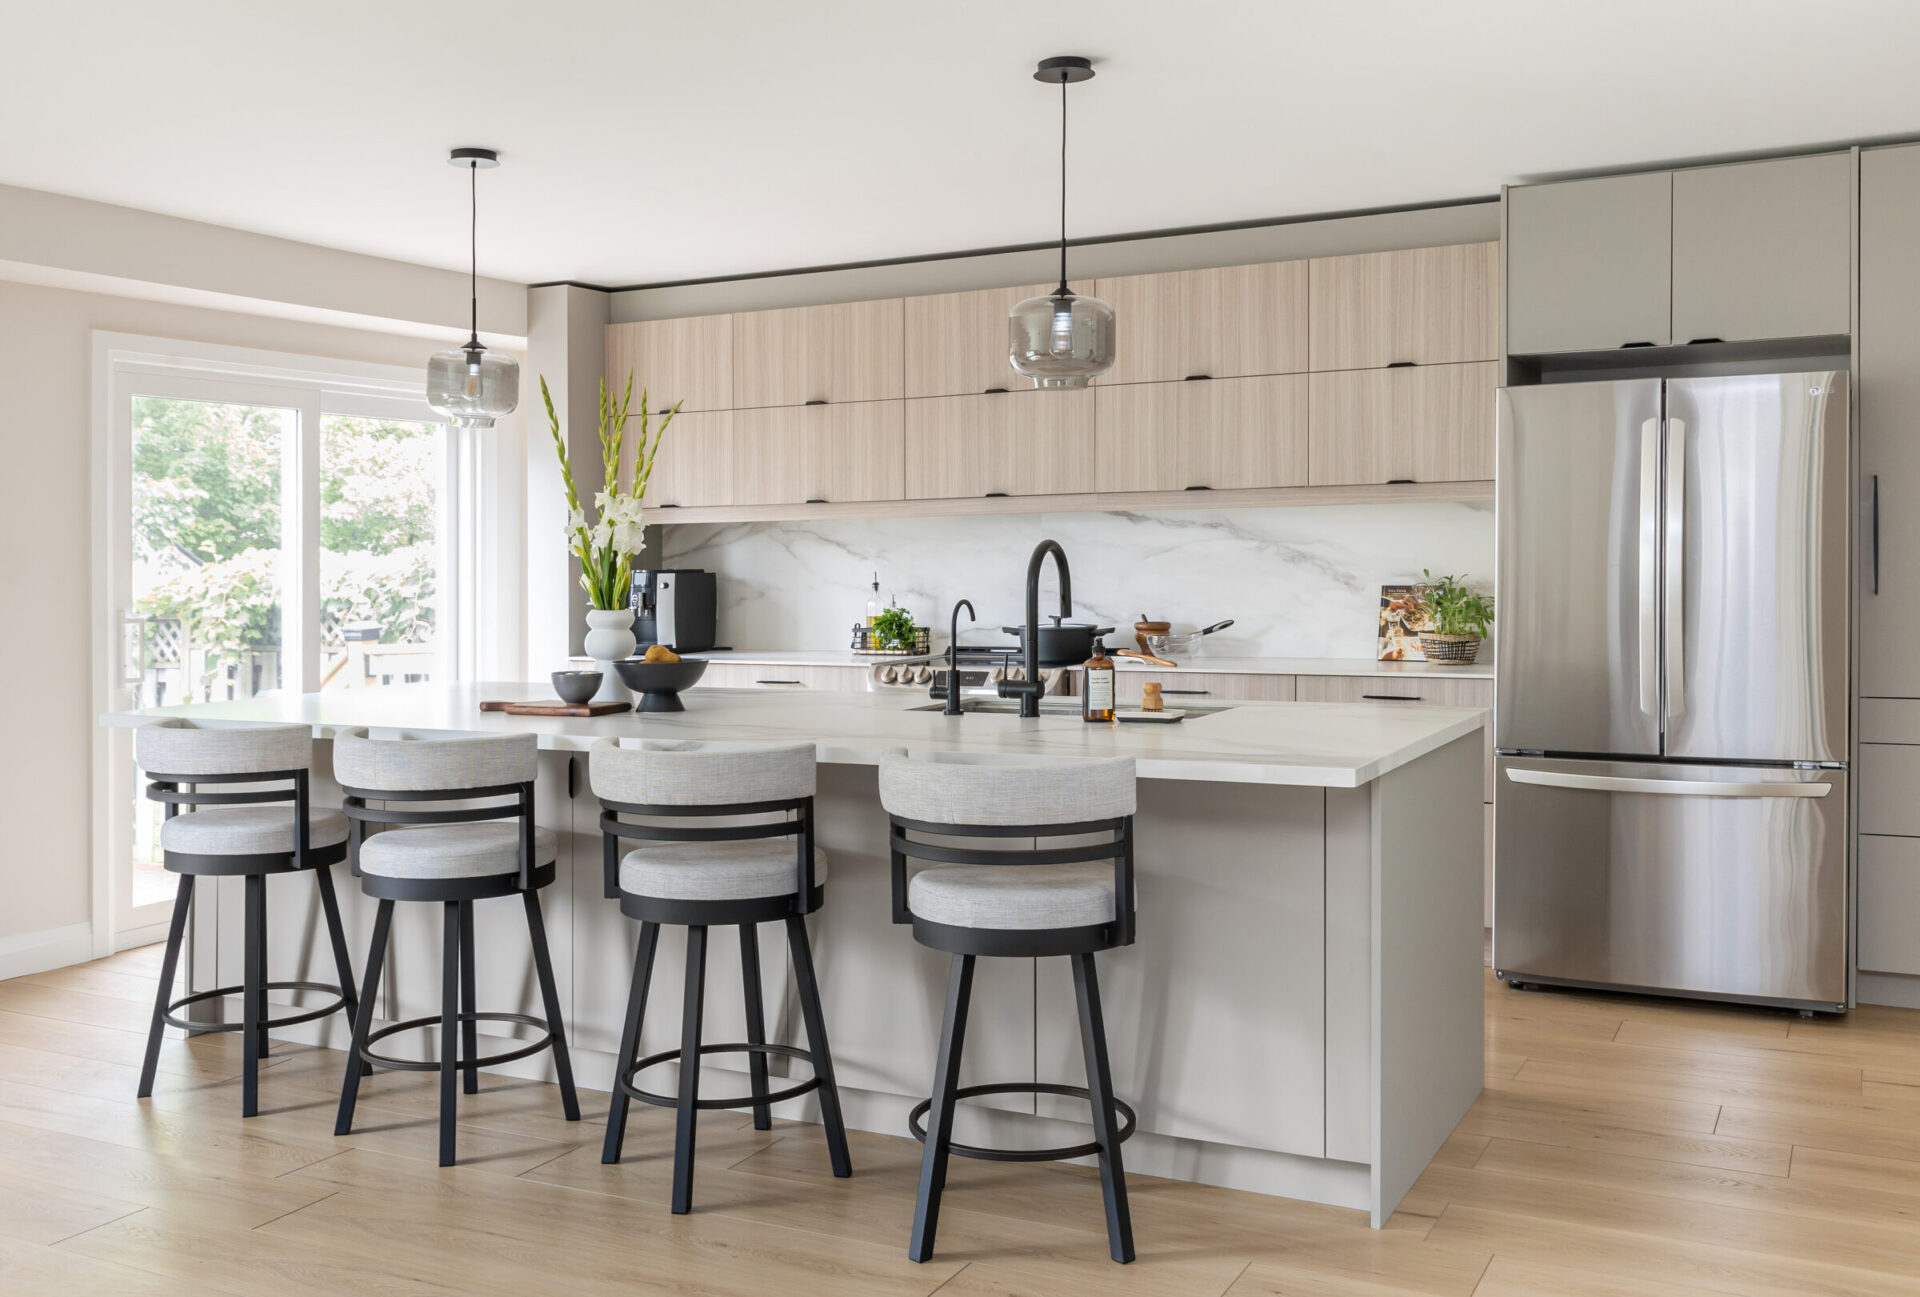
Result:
[334, 729, 540, 888]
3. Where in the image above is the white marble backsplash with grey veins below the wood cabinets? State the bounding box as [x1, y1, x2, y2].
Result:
[660, 505, 1494, 658]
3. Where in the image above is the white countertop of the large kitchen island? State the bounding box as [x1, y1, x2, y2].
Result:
[102, 683, 1486, 789]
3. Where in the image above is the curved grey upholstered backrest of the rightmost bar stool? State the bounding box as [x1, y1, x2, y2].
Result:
[879, 752, 1137, 946]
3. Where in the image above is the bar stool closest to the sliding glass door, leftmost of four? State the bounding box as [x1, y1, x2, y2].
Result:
[132, 719, 353, 1117]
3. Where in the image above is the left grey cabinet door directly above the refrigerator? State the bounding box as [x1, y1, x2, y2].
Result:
[1507, 171, 1672, 355]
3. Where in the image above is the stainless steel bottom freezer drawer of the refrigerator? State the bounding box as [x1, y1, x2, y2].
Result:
[1494, 756, 1847, 1007]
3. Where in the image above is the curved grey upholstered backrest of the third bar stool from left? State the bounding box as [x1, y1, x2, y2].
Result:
[588, 739, 816, 913]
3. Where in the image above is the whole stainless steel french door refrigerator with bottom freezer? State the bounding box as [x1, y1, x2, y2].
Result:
[1494, 372, 1851, 1011]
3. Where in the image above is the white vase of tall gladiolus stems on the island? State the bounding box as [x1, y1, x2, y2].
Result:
[540, 370, 680, 702]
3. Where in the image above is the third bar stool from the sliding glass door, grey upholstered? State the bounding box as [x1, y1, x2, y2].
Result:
[588, 739, 852, 1214]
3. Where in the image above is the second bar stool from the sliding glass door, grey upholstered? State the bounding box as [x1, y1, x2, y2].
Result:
[334, 729, 580, 1167]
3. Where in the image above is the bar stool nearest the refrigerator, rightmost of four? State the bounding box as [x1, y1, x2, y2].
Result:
[879, 754, 1135, 1264]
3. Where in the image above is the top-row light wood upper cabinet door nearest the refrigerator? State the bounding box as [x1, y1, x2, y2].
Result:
[1311, 244, 1500, 370]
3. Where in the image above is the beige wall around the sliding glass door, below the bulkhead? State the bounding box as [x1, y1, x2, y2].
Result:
[0, 282, 524, 950]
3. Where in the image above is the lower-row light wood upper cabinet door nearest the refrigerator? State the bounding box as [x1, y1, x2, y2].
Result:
[1308, 361, 1500, 485]
